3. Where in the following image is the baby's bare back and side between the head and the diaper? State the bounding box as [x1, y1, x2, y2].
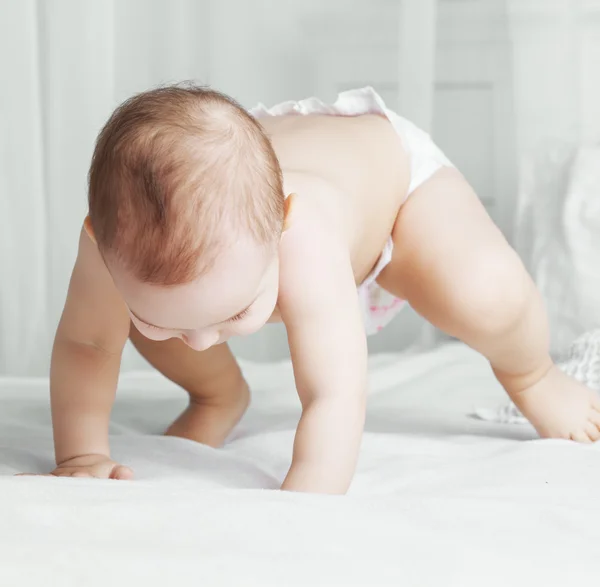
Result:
[260, 114, 410, 283]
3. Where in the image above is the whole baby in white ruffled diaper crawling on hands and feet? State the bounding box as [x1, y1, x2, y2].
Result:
[51, 85, 600, 493]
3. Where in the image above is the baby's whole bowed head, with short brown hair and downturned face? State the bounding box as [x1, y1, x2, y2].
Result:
[86, 86, 285, 350]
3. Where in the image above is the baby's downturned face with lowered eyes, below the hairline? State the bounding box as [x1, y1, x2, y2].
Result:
[109, 241, 279, 351]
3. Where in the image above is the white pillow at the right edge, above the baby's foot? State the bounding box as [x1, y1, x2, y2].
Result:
[515, 144, 600, 357]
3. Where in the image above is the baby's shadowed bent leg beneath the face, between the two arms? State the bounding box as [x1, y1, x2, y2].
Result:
[130, 325, 250, 447]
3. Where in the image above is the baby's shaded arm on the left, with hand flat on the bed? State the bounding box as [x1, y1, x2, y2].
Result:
[50, 230, 131, 478]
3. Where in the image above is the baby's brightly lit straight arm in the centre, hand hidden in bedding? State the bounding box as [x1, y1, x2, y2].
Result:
[279, 200, 367, 493]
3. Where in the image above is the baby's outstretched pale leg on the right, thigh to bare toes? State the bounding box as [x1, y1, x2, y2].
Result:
[378, 168, 600, 442]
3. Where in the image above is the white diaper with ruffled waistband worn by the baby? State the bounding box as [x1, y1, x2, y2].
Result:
[249, 87, 454, 334]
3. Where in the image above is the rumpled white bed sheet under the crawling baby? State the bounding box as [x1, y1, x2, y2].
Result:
[0, 344, 600, 587]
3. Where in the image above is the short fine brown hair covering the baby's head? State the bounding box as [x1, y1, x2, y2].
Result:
[88, 84, 284, 285]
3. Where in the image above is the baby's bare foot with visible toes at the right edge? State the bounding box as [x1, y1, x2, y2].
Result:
[511, 366, 600, 443]
